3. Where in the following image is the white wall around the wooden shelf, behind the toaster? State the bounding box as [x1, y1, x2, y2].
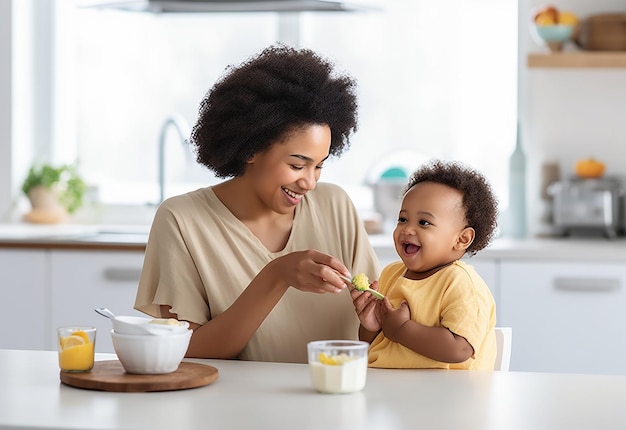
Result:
[519, 0, 626, 234]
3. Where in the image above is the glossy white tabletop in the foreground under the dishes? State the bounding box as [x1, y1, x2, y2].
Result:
[0, 350, 626, 430]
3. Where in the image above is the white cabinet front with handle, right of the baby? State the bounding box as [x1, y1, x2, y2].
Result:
[500, 260, 626, 374]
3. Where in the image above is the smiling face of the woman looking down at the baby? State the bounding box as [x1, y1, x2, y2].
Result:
[244, 125, 331, 214]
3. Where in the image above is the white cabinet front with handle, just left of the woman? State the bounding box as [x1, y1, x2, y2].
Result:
[47, 250, 145, 352]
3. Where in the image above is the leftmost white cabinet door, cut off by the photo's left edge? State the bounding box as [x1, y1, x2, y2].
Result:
[0, 249, 49, 349]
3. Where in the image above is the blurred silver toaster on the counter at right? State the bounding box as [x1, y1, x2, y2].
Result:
[548, 178, 626, 238]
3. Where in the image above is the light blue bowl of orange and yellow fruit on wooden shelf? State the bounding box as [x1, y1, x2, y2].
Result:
[530, 6, 578, 52]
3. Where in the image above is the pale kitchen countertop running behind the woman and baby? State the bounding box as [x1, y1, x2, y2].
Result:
[0, 223, 626, 262]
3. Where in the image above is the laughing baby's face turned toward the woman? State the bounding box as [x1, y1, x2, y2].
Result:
[393, 182, 473, 274]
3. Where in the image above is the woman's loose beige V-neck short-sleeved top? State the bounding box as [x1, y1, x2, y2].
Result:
[135, 183, 379, 362]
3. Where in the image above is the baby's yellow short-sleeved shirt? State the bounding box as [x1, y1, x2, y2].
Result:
[369, 261, 496, 370]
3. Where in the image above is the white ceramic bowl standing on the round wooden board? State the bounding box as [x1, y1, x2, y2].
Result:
[111, 330, 192, 374]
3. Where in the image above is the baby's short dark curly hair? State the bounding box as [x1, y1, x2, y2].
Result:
[402, 160, 498, 255]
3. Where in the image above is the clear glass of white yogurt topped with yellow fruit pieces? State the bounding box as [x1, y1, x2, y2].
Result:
[307, 340, 369, 394]
